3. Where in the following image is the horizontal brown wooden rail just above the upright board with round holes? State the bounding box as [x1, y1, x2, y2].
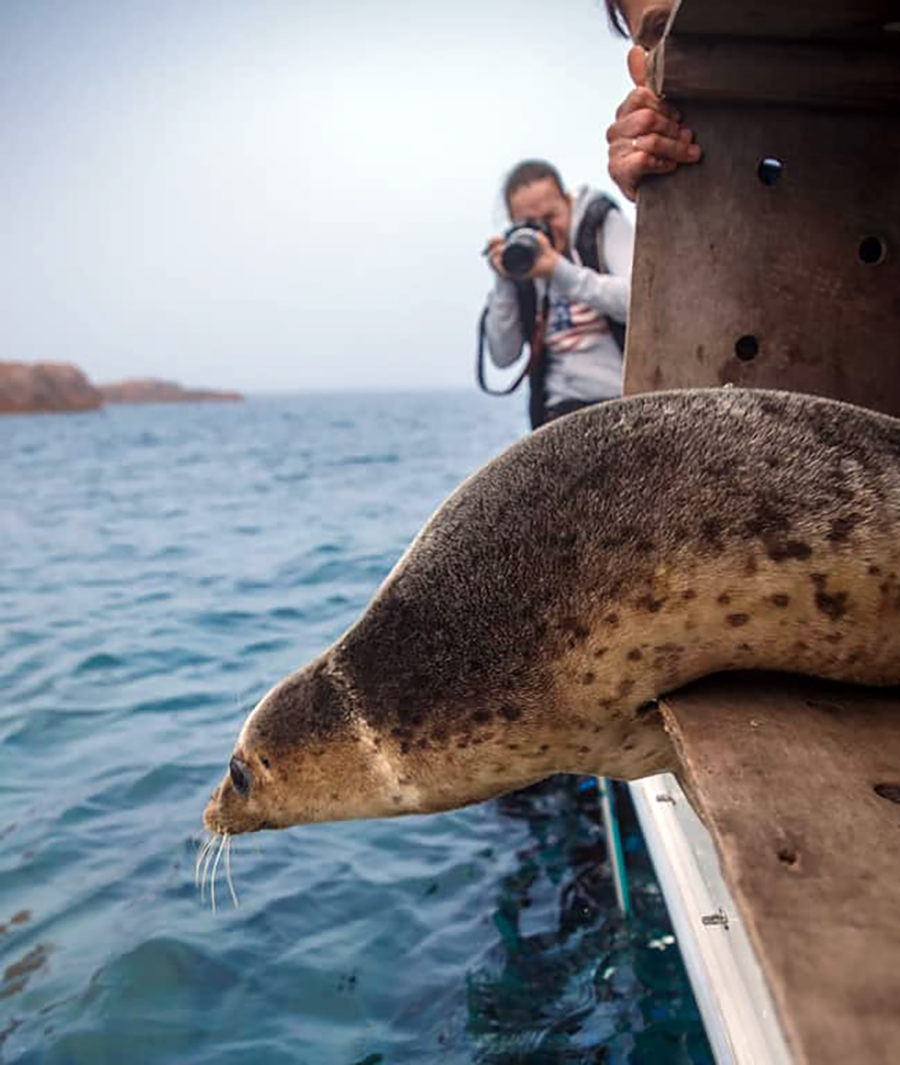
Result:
[649, 34, 900, 114]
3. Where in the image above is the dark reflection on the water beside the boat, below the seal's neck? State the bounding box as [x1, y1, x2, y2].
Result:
[467, 775, 711, 1065]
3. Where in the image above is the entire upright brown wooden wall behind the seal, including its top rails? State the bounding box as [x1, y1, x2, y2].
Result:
[625, 0, 900, 415]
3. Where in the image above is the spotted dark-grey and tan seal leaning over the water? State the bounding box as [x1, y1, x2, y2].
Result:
[204, 389, 900, 836]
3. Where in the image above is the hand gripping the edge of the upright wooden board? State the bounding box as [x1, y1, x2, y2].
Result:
[606, 48, 702, 200]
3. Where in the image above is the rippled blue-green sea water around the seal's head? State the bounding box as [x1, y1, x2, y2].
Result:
[0, 393, 711, 1065]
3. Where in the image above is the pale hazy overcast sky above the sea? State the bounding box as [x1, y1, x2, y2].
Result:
[0, 0, 627, 392]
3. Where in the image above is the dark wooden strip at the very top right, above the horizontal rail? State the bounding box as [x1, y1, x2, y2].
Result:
[671, 0, 900, 40]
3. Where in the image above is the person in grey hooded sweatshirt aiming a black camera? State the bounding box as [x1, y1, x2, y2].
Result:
[479, 160, 633, 428]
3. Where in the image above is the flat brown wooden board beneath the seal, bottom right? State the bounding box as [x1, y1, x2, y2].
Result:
[662, 674, 900, 1065]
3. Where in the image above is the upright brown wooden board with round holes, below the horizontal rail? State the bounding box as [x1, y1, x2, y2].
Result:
[625, 103, 900, 416]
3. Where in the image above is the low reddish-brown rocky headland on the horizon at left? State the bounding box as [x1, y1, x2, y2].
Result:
[0, 361, 244, 414]
